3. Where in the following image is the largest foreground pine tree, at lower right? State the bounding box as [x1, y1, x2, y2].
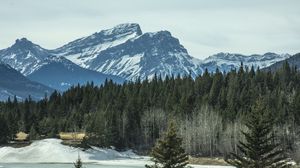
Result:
[226, 99, 286, 168]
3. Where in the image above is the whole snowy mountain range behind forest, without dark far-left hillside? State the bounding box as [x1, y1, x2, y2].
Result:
[0, 23, 291, 100]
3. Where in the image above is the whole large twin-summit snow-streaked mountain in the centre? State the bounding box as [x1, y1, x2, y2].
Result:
[54, 23, 202, 80]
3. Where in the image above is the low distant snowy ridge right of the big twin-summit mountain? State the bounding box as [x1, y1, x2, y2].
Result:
[201, 53, 290, 72]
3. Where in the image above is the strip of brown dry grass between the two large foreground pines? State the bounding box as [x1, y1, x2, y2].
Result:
[189, 156, 228, 166]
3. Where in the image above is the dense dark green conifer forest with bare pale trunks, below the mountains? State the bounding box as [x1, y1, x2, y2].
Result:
[0, 63, 300, 158]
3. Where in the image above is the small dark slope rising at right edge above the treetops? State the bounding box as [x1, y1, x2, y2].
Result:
[264, 53, 300, 72]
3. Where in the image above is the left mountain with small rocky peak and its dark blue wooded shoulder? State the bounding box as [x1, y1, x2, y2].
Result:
[0, 38, 124, 90]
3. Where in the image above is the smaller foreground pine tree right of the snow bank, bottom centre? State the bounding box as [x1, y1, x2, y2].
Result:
[146, 121, 188, 168]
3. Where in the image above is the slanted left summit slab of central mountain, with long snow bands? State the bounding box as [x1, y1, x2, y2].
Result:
[52, 24, 142, 68]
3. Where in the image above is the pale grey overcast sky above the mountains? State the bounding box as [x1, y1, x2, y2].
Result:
[0, 0, 300, 59]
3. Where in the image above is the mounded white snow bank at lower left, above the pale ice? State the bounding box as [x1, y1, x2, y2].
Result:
[0, 139, 146, 163]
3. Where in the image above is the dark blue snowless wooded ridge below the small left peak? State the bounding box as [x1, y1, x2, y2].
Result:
[27, 57, 124, 91]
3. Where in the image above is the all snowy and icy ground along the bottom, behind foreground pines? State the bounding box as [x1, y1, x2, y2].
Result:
[0, 139, 234, 168]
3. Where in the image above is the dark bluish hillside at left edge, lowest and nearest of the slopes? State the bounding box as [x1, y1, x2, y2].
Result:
[0, 62, 53, 101]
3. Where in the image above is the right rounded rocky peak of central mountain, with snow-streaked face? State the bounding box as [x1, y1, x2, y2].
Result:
[89, 31, 202, 80]
